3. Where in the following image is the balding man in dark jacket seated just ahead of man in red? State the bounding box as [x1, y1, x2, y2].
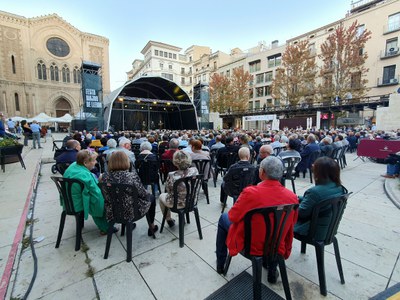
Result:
[220, 147, 256, 203]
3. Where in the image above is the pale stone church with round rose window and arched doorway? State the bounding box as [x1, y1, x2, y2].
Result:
[0, 11, 110, 118]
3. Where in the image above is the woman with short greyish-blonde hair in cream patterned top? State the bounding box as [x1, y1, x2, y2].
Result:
[159, 151, 199, 227]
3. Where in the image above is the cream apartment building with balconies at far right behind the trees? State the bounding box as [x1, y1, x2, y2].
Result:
[287, 0, 400, 101]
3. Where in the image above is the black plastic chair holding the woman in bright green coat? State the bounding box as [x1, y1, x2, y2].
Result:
[51, 176, 84, 251]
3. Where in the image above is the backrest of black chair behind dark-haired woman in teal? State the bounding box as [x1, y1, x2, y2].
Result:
[307, 191, 351, 245]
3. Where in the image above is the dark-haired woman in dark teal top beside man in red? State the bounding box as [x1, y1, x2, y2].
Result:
[294, 156, 347, 240]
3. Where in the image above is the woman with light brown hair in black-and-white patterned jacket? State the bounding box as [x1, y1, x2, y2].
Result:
[99, 151, 158, 236]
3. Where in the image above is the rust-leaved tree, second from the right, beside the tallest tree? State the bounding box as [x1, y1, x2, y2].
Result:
[272, 41, 317, 105]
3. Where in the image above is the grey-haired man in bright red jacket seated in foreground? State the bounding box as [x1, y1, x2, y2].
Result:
[216, 156, 299, 283]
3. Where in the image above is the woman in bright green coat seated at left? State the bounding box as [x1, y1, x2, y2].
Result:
[64, 150, 110, 235]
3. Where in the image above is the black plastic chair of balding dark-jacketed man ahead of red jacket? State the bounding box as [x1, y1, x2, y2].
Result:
[221, 167, 258, 214]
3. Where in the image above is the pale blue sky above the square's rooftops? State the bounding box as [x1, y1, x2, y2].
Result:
[0, 0, 351, 90]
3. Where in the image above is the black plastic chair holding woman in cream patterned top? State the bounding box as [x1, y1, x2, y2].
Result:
[160, 175, 203, 248]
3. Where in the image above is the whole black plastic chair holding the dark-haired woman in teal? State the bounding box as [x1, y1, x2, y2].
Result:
[294, 193, 351, 296]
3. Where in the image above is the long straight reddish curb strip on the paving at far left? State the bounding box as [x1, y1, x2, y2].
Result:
[0, 162, 40, 299]
